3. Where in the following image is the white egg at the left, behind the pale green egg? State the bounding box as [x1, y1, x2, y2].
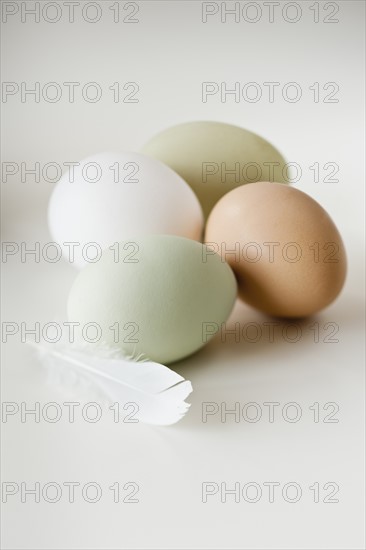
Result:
[48, 152, 203, 267]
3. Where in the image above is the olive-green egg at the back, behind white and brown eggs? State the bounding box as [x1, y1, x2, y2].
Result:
[142, 121, 287, 217]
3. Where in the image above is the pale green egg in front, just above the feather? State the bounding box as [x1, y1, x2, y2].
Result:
[68, 235, 237, 364]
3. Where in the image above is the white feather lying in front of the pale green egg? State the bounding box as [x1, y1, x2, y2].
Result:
[29, 342, 192, 426]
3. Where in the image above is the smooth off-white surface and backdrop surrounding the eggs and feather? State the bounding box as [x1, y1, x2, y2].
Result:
[2, 1, 364, 550]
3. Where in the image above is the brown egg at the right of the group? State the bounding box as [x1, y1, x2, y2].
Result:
[205, 182, 346, 317]
